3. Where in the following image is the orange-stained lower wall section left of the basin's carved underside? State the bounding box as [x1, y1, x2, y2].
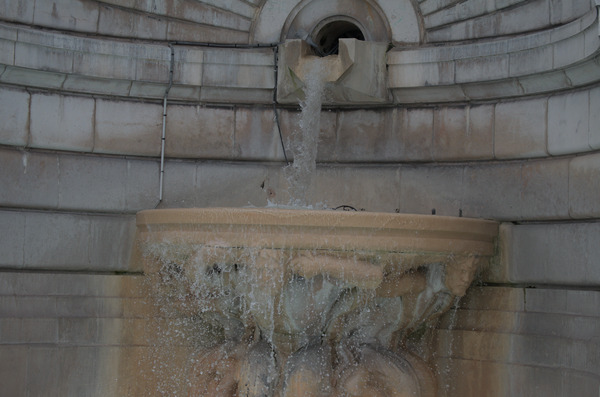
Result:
[0, 273, 149, 396]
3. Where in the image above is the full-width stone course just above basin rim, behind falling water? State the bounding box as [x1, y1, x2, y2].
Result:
[0, 149, 600, 223]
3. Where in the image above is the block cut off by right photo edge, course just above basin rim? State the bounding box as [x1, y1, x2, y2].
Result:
[569, 154, 600, 218]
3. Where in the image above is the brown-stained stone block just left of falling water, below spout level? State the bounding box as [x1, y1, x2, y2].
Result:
[232, 107, 288, 161]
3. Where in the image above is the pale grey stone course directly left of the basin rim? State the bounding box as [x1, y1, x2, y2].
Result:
[0, 211, 139, 271]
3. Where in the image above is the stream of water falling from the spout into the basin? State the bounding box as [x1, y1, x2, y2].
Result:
[284, 59, 325, 207]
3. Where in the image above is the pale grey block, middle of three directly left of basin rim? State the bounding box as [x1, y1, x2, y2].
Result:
[24, 212, 90, 269]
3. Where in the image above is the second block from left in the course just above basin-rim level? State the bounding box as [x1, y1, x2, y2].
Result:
[58, 156, 127, 212]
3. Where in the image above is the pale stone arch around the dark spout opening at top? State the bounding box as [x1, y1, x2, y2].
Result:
[250, 0, 422, 44]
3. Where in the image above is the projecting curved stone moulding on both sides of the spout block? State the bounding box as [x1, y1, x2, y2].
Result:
[0, 9, 600, 104]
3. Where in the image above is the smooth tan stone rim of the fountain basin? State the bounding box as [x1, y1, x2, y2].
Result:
[136, 208, 498, 270]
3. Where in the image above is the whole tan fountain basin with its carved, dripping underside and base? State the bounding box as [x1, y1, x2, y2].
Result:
[133, 208, 498, 396]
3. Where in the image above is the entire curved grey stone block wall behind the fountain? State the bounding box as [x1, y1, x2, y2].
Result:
[0, 0, 600, 396]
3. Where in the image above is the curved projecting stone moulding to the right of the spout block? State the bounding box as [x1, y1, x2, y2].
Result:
[388, 9, 600, 103]
